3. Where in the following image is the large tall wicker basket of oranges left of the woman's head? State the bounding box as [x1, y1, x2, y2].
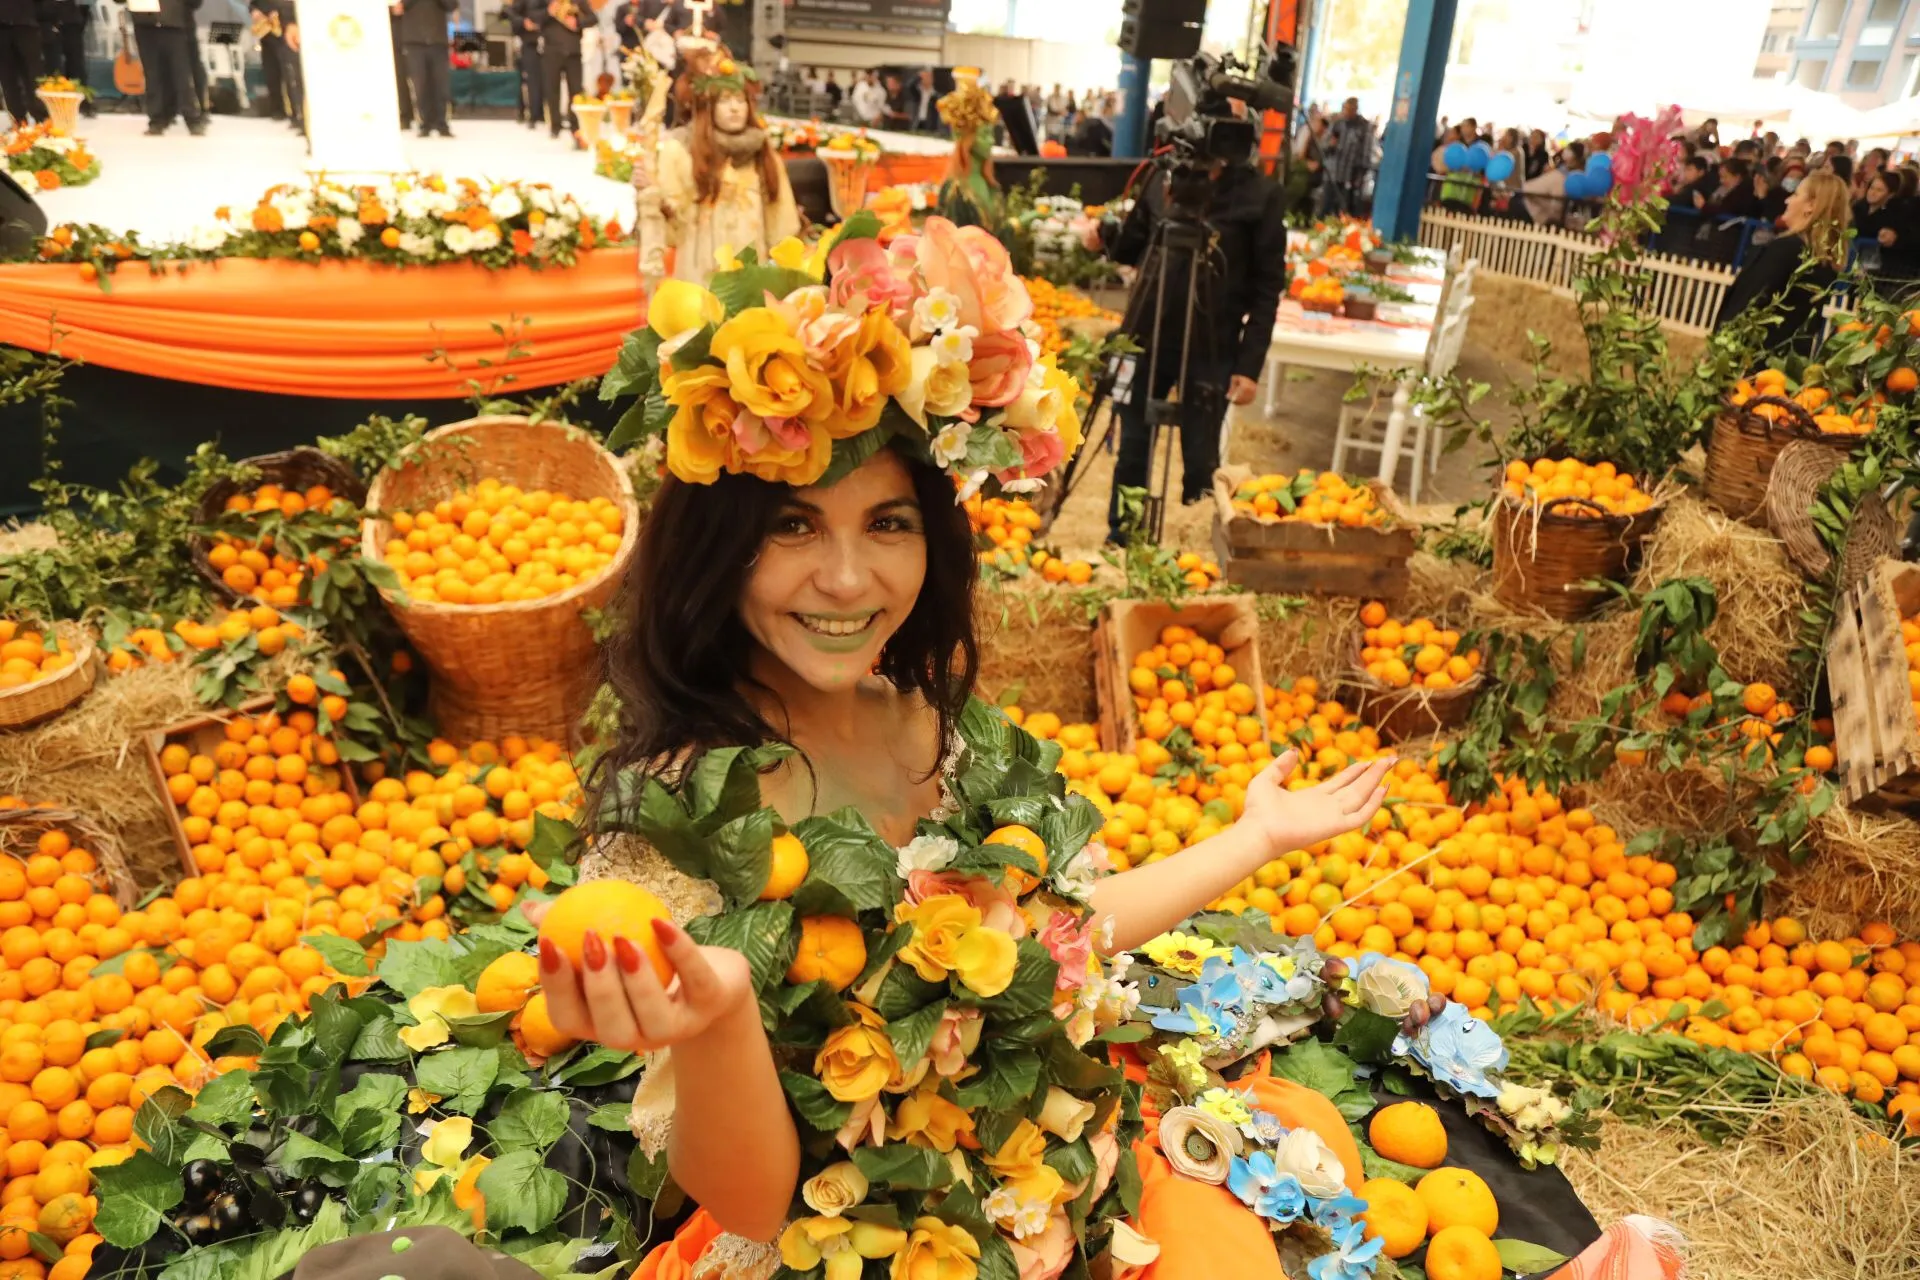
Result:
[361, 416, 639, 743]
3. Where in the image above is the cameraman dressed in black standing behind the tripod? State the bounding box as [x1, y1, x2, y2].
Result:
[1089, 112, 1286, 543]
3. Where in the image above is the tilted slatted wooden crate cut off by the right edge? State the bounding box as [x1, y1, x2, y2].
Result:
[1826, 560, 1920, 810]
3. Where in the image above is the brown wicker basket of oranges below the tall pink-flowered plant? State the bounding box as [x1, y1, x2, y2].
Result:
[1494, 495, 1663, 622]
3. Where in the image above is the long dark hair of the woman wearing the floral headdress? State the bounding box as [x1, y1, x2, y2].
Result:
[586, 455, 979, 825]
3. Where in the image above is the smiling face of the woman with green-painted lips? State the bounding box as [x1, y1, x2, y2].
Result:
[739, 449, 927, 693]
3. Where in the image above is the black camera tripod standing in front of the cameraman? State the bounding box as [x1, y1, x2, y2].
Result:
[1052, 161, 1227, 543]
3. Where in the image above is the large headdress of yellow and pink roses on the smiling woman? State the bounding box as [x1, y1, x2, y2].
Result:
[601, 211, 1081, 497]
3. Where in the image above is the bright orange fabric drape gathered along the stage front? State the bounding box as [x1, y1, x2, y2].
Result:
[0, 246, 641, 399]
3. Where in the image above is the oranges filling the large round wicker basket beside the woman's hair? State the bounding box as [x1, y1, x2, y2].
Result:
[384, 476, 626, 604]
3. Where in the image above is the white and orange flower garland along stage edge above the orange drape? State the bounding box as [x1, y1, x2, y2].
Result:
[15, 175, 626, 276]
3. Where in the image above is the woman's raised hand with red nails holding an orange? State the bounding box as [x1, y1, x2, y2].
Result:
[526, 902, 758, 1054]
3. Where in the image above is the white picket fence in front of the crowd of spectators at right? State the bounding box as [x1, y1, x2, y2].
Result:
[1421, 209, 1734, 334]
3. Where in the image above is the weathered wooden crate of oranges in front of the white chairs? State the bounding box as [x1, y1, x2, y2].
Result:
[1213, 466, 1415, 601]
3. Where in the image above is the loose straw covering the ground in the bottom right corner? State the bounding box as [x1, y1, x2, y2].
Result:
[1565, 1098, 1920, 1280]
